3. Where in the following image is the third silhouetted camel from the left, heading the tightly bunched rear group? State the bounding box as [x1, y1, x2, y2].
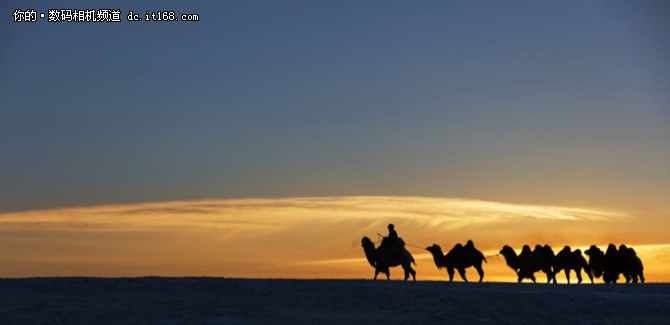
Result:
[500, 245, 556, 283]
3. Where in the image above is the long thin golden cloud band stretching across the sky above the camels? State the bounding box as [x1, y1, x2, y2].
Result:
[0, 197, 628, 231]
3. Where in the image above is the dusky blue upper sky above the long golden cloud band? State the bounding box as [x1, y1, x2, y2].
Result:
[0, 1, 670, 211]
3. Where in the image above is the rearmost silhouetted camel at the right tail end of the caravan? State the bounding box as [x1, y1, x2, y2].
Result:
[585, 244, 645, 283]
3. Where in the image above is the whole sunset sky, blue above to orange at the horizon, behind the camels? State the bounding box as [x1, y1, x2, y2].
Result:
[0, 1, 670, 281]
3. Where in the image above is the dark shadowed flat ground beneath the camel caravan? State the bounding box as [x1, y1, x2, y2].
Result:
[0, 277, 670, 325]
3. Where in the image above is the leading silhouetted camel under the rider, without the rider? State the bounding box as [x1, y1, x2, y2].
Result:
[361, 237, 416, 281]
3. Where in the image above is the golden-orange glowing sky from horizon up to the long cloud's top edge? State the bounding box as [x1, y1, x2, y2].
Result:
[0, 197, 670, 281]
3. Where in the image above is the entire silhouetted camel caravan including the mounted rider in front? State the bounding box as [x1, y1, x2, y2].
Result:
[361, 224, 644, 283]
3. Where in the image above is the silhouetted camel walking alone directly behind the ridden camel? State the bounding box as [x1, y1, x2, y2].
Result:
[426, 240, 488, 282]
